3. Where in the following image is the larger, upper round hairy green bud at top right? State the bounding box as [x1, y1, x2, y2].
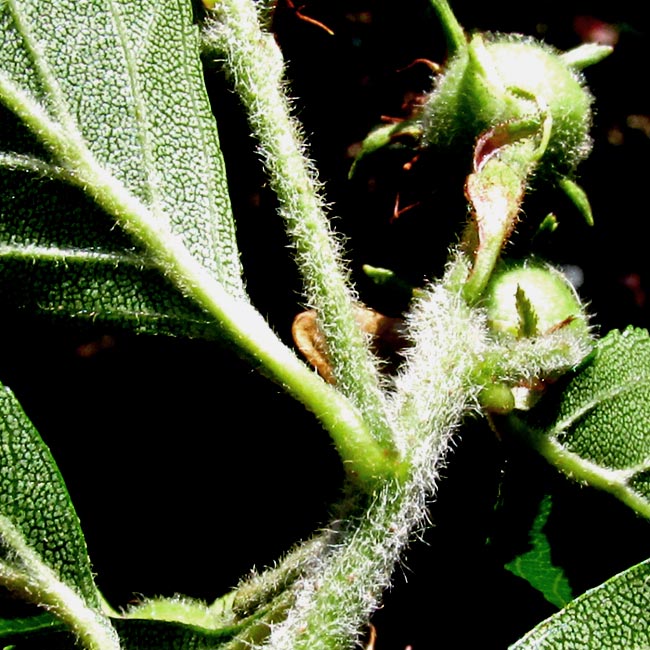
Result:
[421, 34, 592, 176]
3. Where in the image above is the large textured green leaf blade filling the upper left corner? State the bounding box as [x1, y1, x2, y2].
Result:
[0, 0, 244, 334]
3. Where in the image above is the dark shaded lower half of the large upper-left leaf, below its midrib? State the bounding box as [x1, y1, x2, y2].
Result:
[0, 150, 216, 338]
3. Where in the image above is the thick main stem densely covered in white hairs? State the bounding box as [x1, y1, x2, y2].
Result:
[267, 268, 484, 650]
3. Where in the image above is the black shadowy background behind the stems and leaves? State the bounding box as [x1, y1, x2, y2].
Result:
[0, 0, 650, 650]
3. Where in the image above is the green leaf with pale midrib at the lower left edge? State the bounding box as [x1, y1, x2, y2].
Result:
[0, 385, 119, 650]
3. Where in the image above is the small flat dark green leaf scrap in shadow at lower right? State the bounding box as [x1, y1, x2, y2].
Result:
[505, 495, 573, 608]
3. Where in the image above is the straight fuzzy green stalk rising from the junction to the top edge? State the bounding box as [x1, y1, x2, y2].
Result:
[204, 0, 396, 457]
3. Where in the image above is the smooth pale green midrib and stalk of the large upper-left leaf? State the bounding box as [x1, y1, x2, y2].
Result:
[0, 63, 398, 490]
